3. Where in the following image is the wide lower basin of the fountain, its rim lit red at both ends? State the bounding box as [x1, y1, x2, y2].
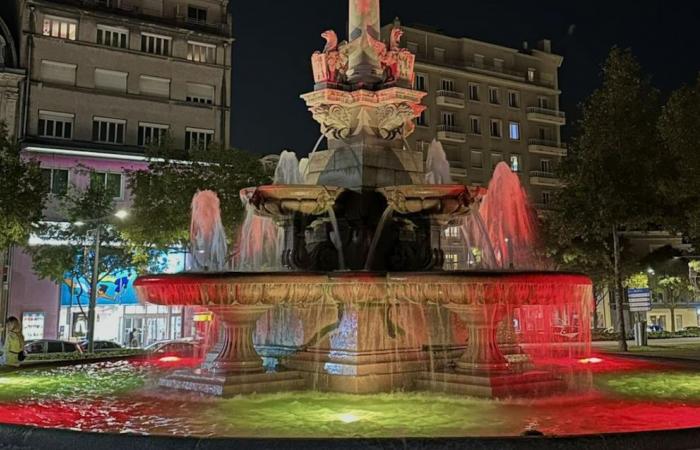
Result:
[135, 272, 592, 307]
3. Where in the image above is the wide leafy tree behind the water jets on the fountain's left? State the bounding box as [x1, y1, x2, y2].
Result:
[125, 140, 270, 249]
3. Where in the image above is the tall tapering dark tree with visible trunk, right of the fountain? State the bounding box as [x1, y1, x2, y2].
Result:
[548, 48, 666, 351]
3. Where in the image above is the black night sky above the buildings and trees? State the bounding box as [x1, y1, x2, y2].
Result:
[231, 0, 700, 155]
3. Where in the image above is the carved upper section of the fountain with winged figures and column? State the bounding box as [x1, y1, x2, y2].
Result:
[302, 0, 426, 191]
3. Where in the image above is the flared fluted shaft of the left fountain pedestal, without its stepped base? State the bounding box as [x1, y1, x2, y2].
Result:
[207, 305, 272, 375]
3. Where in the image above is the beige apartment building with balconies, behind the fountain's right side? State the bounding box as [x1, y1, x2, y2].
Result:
[382, 20, 566, 209]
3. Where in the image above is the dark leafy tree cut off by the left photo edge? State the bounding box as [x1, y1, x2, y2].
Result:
[0, 122, 48, 252]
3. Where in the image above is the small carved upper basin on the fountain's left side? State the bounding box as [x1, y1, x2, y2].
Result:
[241, 184, 345, 218]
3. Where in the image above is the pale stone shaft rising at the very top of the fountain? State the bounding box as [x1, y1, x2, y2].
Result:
[347, 0, 383, 85]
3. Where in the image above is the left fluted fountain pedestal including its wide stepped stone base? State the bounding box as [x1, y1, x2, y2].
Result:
[160, 305, 305, 397]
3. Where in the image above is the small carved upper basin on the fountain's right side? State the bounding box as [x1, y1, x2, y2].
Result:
[377, 184, 474, 217]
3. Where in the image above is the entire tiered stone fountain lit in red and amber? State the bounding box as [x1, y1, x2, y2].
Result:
[137, 0, 592, 397]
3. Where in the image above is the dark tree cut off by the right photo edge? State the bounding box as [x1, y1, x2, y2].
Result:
[659, 74, 700, 240]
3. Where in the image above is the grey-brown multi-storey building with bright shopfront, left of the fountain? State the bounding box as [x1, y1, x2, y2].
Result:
[8, 0, 233, 344]
